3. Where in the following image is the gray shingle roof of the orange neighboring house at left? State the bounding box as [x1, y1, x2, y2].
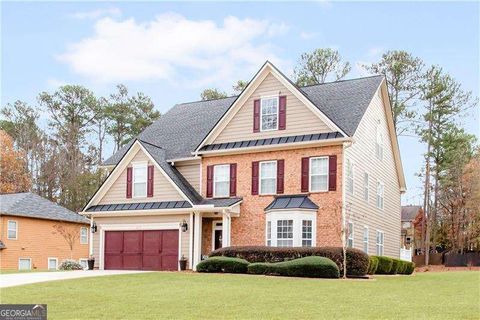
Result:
[0, 192, 89, 223]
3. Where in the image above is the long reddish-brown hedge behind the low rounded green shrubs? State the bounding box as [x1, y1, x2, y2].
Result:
[210, 246, 368, 276]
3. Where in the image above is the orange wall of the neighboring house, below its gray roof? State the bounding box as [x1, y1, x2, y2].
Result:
[0, 215, 91, 270]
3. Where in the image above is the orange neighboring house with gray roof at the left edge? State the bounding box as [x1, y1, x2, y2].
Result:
[0, 192, 90, 270]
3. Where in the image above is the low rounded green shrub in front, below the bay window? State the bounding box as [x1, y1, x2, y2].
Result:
[248, 256, 340, 278]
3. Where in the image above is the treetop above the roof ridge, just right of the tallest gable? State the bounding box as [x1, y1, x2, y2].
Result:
[294, 48, 351, 86]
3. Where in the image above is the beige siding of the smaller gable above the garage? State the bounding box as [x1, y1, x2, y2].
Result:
[99, 150, 185, 204]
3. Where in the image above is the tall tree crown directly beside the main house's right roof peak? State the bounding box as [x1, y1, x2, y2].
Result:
[363, 50, 424, 135]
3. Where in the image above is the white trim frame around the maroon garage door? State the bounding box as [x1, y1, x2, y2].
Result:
[98, 222, 182, 270]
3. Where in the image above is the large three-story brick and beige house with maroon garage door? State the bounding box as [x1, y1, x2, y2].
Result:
[81, 62, 405, 270]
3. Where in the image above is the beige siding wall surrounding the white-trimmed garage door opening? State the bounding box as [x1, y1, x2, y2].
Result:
[92, 213, 190, 268]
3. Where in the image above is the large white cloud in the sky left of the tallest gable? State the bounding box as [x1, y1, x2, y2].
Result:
[58, 13, 288, 86]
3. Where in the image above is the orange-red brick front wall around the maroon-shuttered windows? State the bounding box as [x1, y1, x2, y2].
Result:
[202, 145, 343, 253]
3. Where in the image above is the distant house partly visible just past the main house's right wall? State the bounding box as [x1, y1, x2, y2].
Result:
[401, 205, 423, 250]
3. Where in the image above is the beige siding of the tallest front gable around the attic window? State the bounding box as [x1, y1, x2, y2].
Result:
[213, 74, 332, 143]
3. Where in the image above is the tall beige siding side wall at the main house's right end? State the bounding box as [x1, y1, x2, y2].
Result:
[346, 89, 401, 257]
